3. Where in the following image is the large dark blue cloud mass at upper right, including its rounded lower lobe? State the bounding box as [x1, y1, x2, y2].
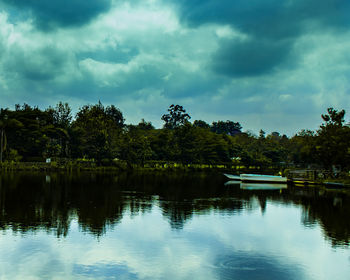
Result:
[165, 0, 350, 77]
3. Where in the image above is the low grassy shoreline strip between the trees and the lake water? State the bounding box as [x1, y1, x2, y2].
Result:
[0, 160, 350, 190]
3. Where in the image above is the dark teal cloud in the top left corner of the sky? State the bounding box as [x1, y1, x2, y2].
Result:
[0, 0, 111, 30]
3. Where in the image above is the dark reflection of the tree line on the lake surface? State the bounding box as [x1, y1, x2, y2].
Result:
[0, 173, 350, 246]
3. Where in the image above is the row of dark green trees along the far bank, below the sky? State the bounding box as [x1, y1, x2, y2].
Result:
[0, 102, 350, 170]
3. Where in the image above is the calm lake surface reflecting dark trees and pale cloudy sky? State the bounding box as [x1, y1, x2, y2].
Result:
[0, 173, 350, 280]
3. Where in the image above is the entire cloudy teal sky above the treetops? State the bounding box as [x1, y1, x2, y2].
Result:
[0, 0, 350, 135]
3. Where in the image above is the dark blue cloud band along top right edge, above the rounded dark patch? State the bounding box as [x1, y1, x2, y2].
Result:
[170, 0, 350, 34]
